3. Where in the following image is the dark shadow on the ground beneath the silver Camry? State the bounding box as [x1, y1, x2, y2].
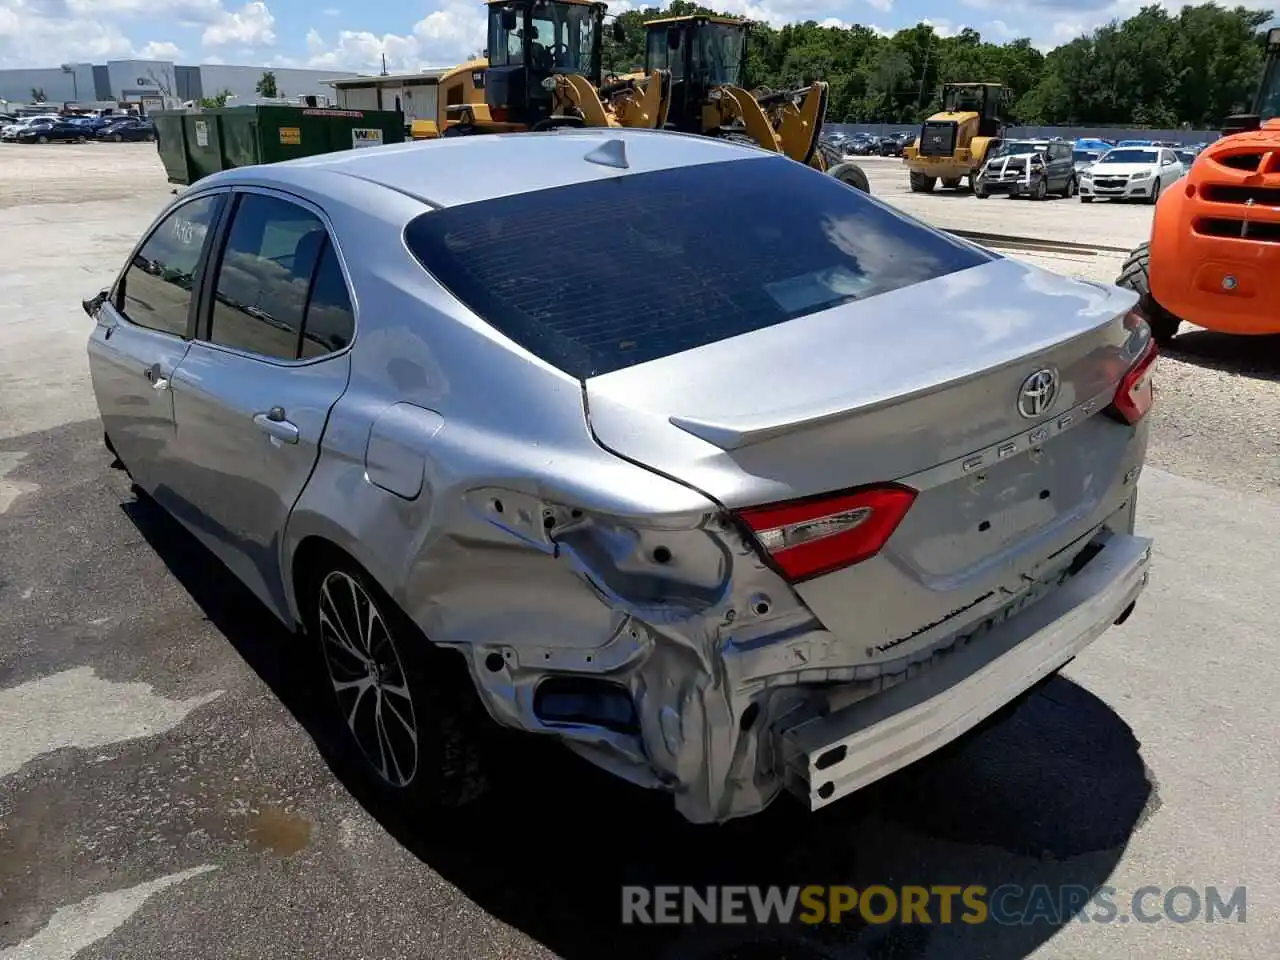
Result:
[123, 488, 1158, 960]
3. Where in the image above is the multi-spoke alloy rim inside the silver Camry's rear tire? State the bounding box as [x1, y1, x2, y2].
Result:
[317, 570, 419, 787]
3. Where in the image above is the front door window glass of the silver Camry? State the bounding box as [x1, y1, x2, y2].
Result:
[116, 196, 223, 337]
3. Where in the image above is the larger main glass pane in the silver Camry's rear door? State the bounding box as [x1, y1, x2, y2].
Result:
[209, 193, 328, 360]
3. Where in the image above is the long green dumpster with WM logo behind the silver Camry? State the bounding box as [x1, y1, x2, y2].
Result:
[151, 106, 404, 186]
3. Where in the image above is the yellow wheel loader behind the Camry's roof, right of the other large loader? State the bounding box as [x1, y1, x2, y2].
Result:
[644, 14, 869, 192]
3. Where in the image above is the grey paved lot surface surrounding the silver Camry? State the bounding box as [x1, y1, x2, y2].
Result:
[0, 145, 1280, 960]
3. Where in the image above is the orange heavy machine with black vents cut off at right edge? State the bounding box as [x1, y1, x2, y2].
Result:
[1116, 27, 1280, 343]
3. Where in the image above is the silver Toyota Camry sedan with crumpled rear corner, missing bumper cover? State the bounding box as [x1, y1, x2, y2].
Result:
[84, 129, 1155, 822]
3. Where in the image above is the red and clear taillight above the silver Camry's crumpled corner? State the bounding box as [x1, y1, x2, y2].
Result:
[736, 484, 915, 581]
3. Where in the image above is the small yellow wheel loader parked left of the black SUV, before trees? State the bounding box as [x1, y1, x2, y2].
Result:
[902, 83, 1009, 193]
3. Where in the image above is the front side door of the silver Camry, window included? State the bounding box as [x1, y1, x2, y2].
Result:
[88, 193, 224, 500]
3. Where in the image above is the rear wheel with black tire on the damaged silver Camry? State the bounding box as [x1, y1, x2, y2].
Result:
[298, 552, 492, 812]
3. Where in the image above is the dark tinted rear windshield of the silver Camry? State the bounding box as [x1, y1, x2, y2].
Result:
[404, 157, 992, 379]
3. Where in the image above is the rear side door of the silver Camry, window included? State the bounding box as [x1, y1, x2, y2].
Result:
[173, 189, 355, 616]
